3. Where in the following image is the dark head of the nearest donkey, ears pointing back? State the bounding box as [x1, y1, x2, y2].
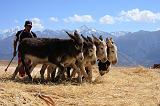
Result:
[66, 31, 84, 60]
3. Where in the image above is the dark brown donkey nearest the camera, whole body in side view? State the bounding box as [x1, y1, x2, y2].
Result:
[13, 31, 84, 83]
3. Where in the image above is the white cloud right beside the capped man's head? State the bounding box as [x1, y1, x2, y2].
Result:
[31, 18, 44, 30]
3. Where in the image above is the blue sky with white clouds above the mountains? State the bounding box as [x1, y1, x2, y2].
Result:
[0, 0, 160, 33]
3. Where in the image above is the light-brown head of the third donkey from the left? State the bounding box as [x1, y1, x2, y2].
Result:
[92, 35, 107, 62]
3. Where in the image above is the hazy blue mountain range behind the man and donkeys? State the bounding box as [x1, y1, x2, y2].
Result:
[0, 25, 160, 66]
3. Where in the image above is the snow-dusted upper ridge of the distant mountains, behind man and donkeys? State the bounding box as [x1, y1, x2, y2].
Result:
[0, 25, 113, 40]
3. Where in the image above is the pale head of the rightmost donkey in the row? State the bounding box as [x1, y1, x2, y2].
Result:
[106, 38, 118, 65]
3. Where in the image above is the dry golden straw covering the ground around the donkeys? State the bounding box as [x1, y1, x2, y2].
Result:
[0, 60, 160, 106]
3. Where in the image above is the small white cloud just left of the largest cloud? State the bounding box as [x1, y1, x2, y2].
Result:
[99, 15, 114, 24]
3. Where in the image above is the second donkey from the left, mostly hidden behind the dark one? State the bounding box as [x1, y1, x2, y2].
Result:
[41, 35, 97, 80]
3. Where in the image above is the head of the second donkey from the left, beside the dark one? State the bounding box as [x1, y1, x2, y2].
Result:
[81, 35, 97, 64]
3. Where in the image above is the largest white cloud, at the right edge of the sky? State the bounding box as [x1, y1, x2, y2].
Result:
[119, 9, 160, 23]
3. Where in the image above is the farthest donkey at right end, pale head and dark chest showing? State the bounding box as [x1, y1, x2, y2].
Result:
[98, 38, 118, 76]
